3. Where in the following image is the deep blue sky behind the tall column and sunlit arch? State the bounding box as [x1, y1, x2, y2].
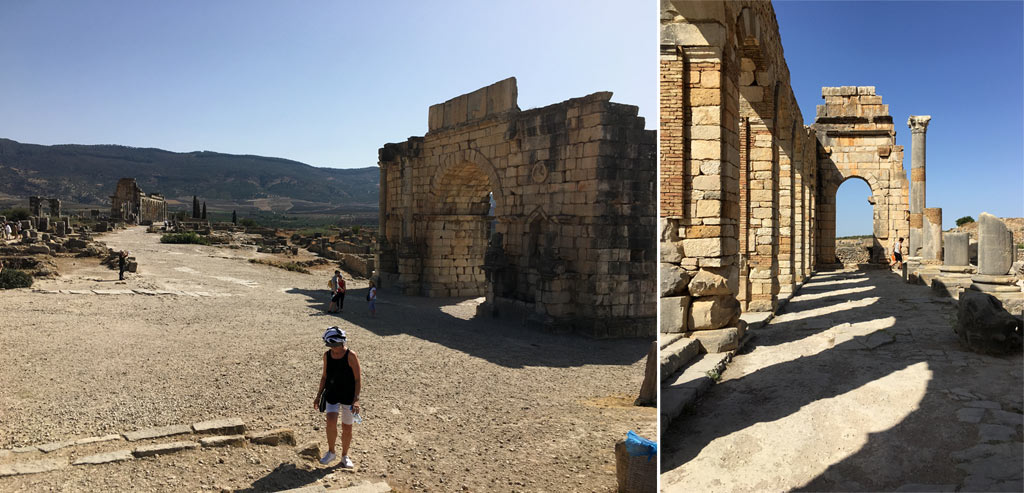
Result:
[774, 1, 1024, 236]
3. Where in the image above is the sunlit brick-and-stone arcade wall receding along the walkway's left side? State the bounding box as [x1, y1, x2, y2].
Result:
[660, 1, 816, 342]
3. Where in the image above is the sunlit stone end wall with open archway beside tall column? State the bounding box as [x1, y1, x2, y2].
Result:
[812, 86, 910, 263]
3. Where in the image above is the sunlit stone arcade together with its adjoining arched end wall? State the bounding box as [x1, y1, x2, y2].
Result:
[659, 1, 910, 352]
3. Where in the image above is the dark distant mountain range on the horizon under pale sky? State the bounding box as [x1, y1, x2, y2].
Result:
[0, 138, 380, 209]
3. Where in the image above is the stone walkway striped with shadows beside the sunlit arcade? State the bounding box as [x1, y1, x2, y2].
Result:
[662, 271, 1024, 492]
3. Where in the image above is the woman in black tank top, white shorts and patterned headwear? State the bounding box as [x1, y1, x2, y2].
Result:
[313, 327, 362, 467]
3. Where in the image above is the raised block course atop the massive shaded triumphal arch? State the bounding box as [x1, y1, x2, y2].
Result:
[427, 77, 519, 133]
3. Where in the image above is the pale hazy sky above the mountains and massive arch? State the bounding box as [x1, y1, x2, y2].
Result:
[0, 0, 657, 168]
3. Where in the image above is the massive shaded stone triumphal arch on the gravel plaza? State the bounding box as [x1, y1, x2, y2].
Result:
[378, 78, 656, 337]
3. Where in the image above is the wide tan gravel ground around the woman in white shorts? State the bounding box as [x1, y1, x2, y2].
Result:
[0, 228, 656, 491]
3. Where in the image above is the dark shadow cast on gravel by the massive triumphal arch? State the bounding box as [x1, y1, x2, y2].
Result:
[286, 288, 650, 368]
